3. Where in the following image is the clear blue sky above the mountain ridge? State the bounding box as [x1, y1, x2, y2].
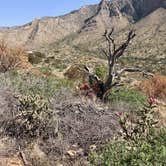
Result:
[0, 0, 100, 26]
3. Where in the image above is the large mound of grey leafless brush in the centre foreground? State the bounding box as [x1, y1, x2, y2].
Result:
[50, 98, 119, 153]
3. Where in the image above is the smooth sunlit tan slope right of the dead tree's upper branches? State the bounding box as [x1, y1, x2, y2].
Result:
[126, 8, 166, 58]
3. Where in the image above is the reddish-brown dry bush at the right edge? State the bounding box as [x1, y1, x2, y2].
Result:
[139, 74, 166, 99]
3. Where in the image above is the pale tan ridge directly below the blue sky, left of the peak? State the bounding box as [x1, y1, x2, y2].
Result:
[0, 5, 97, 47]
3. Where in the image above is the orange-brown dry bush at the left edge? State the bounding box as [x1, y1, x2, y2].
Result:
[0, 40, 30, 72]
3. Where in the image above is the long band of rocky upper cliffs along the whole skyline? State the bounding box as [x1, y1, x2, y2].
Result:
[0, 0, 166, 47]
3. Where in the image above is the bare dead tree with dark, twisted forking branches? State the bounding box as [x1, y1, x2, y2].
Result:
[85, 29, 153, 100]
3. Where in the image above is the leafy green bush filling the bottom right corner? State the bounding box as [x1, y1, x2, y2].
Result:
[89, 129, 166, 166]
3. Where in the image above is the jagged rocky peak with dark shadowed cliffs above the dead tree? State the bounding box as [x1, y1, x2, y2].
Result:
[83, 0, 165, 31]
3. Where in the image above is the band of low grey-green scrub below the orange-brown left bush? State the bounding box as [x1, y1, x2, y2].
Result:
[0, 71, 74, 99]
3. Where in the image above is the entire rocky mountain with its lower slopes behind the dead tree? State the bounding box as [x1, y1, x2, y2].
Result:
[0, 0, 166, 74]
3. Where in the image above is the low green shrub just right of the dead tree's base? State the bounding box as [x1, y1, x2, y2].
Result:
[108, 88, 147, 109]
